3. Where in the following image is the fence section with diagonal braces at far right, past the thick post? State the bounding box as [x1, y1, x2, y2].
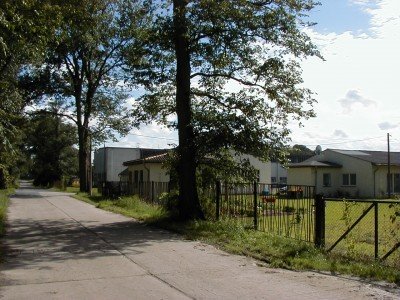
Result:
[320, 198, 400, 267]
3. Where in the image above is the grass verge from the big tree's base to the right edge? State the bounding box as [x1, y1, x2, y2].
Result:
[156, 219, 400, 285]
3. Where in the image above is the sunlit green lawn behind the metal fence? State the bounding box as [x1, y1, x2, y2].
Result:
[216, 195, 400, 268]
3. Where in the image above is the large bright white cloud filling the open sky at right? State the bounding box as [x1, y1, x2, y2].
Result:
[293, 0, 400, 151]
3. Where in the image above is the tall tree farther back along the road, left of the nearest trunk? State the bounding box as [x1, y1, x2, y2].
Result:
[30, 0, 151, 191]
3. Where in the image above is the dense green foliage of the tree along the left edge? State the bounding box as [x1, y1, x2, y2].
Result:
[0, 0, 58, 187]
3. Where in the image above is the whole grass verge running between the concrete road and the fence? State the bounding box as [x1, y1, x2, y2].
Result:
[75, 193, 400, 285]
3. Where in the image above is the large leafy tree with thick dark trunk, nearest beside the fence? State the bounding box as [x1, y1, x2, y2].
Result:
[131, 0, 319, 219]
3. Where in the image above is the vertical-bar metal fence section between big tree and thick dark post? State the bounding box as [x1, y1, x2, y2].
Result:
[215, 182, 315, 242]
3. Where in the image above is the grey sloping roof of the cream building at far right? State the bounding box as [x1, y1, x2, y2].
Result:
[329, 149, 400, 165]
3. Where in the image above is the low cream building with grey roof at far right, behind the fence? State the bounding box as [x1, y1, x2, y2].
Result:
[288, 149, 400, 198]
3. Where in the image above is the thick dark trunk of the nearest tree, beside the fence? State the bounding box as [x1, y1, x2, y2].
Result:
[174, 0, 204, 220]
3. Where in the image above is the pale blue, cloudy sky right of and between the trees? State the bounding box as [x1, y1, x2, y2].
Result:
[106, 0, 400, 151]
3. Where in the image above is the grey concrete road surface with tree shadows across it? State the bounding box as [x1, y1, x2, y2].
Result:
[0, 182, 400, 299]
